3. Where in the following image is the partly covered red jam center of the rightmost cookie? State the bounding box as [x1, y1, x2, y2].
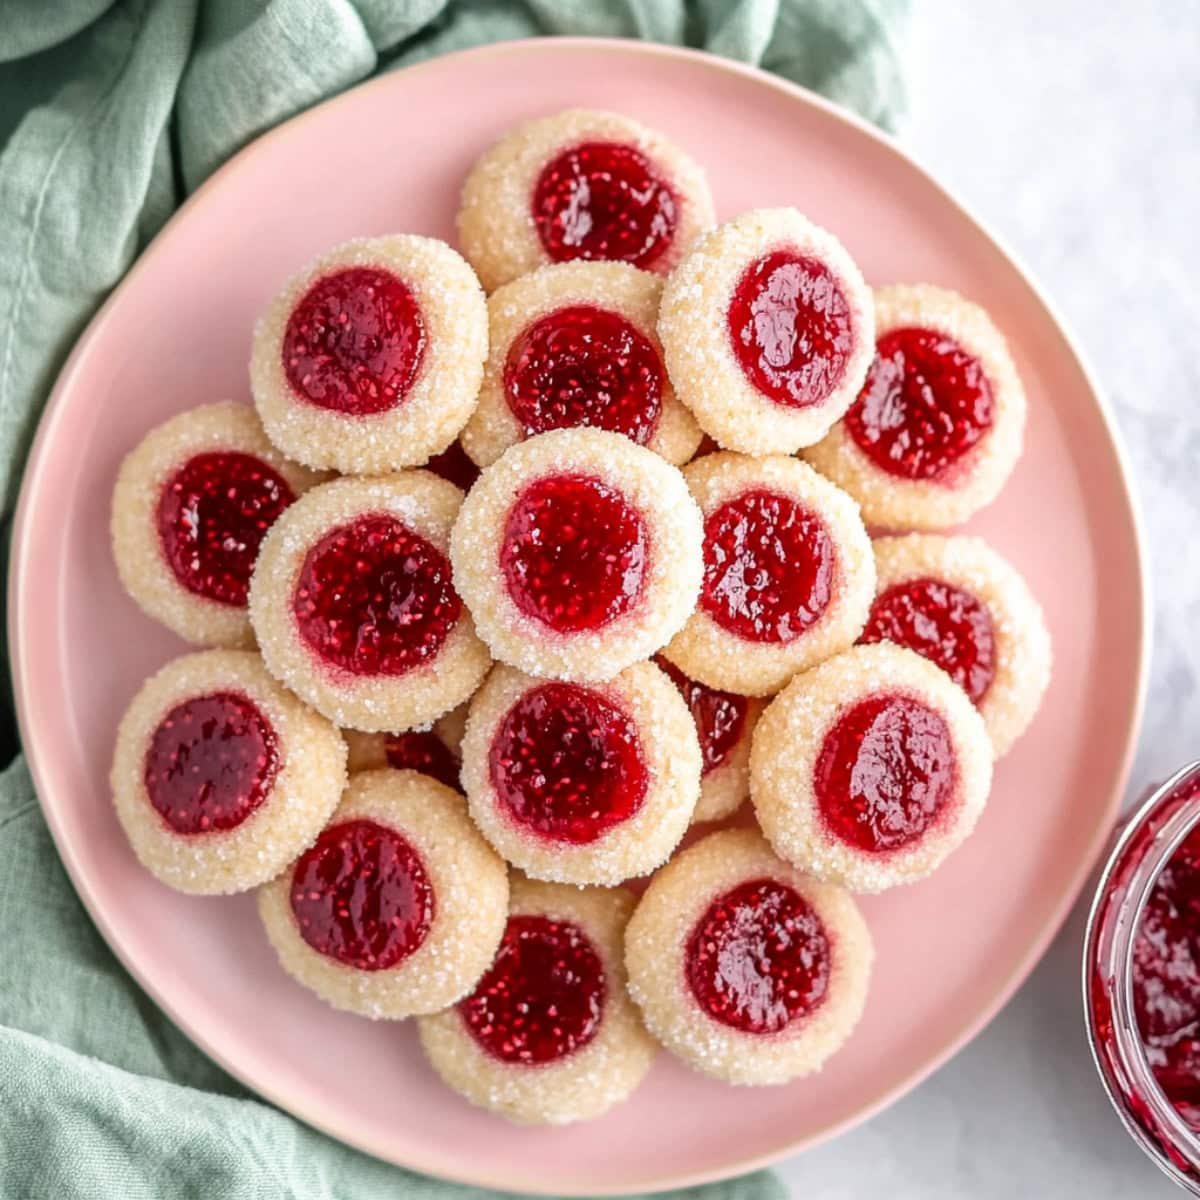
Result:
[859, 580, 996, 704]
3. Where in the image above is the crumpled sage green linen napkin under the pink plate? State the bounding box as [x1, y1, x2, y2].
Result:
[0, 0, 907, 1200]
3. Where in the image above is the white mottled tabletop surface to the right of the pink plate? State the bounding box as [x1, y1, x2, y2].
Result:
[781, 0, 1200, 1200]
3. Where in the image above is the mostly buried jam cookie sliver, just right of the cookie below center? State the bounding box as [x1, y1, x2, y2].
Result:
[654, 654, 763, 824]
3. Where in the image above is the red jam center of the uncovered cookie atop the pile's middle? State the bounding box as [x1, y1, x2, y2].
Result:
[500, 475, 650, 634]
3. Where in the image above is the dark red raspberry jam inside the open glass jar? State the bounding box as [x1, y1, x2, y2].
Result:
[1133, 780, 1200, 1128]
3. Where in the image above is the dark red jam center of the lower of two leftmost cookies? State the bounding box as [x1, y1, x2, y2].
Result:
[143, 691, 281, 834]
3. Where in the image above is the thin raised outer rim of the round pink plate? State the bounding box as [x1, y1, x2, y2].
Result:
[7, 36, 1153, 1195]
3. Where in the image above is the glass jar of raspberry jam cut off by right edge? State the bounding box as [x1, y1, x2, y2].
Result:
[1084, 762, 1200, 1196]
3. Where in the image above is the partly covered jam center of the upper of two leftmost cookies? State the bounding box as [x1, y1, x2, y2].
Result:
[156, 450, 295, 607]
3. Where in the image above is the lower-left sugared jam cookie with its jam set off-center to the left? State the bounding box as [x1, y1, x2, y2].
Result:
[258, 768, 509, 1020]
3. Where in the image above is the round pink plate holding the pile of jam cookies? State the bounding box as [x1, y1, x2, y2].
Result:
[11, 40, 1146, 1194]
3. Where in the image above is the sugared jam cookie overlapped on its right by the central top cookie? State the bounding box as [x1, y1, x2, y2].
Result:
[250, 470, 491, 732]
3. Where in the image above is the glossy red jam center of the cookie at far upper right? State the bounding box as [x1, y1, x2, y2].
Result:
[846, 329, 996, 480]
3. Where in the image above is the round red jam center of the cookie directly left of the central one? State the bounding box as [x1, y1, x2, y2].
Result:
[292, 514, 462, 676]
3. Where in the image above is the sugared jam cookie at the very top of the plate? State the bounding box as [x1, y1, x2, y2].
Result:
[458, 108, 714, 292]
